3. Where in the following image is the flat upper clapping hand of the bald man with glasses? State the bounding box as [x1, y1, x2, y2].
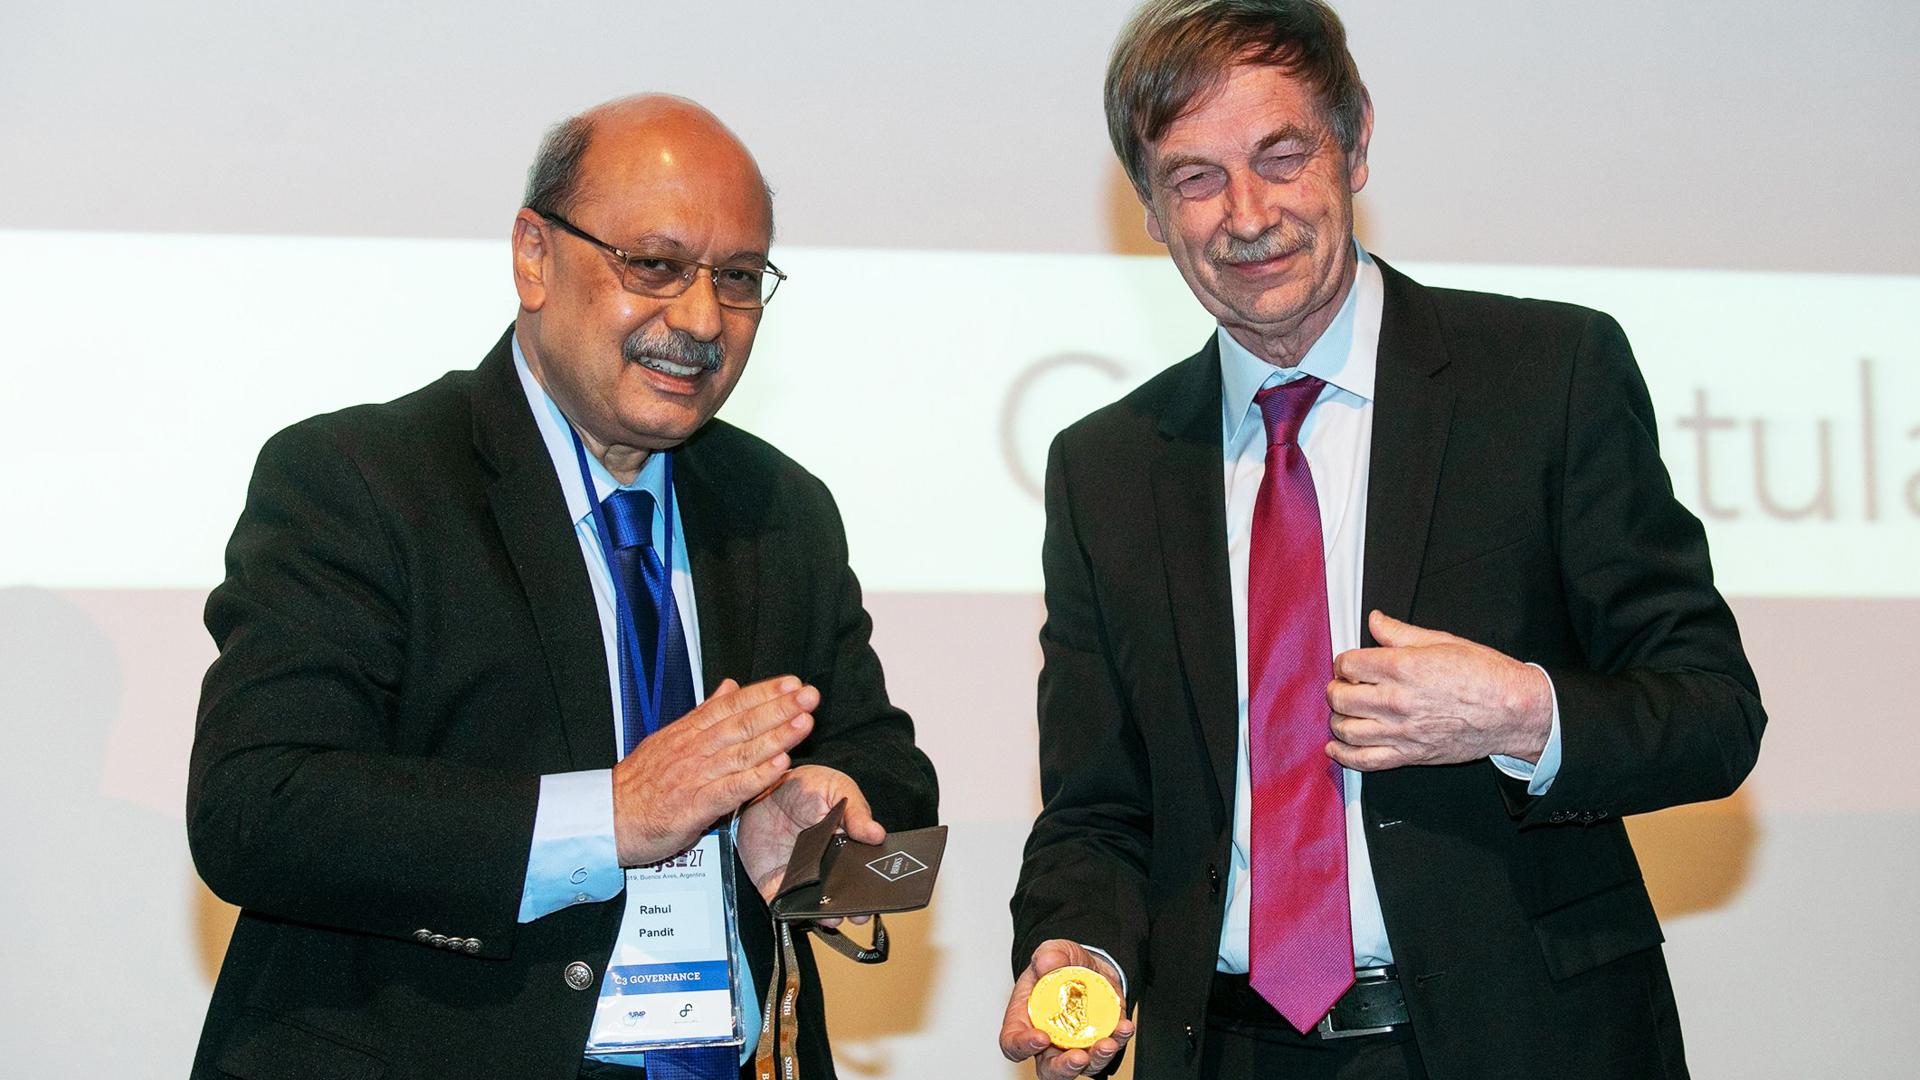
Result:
[612, 675, 820, 867]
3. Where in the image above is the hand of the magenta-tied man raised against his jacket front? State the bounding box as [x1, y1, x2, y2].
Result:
[1327, 611, 1553, 773]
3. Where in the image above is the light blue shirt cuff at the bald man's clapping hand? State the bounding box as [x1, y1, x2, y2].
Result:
[520, 769, 626, 922]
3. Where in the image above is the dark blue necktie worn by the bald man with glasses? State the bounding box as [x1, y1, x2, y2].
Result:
[607, 490, 739, 1080]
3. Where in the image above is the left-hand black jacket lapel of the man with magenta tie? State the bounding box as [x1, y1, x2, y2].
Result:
[1152, 338, 1238, 807]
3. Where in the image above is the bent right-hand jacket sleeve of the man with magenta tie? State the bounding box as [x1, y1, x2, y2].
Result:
[1505, 313, 1766, 824]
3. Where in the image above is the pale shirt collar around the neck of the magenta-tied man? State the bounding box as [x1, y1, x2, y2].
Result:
[1215, 240, 1384, 446]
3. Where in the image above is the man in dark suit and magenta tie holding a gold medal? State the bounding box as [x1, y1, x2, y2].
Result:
[1000, 0, 1766, 1080]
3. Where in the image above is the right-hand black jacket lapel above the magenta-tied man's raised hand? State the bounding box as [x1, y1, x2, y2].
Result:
[1359, 259, 1453, 634]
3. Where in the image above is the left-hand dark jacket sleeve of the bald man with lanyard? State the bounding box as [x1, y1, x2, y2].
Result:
[186, 419, 540, 955]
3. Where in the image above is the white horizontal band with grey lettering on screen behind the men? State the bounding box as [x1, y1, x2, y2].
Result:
[0, 231, 1920, 596]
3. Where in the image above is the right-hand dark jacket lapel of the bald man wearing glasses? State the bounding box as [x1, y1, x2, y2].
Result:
[674, 423, 760, 692]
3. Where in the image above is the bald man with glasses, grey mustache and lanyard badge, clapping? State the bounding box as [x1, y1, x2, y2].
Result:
[186, 96, 935, 1080]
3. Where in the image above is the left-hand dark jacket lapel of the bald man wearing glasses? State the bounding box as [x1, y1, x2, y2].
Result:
[472, 331, 616, 769]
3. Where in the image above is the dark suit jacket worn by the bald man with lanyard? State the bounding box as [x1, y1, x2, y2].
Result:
[186, 328, 935, 1080]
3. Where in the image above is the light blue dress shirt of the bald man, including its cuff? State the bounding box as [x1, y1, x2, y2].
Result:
[513, 338, 760, 1065]
